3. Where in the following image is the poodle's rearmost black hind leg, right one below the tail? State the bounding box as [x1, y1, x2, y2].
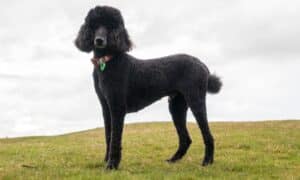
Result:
[184, 88, 214, 166]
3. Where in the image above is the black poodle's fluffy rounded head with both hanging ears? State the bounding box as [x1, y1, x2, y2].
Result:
[75, 6, 132, 56]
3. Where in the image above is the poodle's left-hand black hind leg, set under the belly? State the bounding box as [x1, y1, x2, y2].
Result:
[167, 94, 192, 162]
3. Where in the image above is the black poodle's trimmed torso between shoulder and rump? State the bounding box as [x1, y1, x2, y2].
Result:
[126, 54, 218, 112]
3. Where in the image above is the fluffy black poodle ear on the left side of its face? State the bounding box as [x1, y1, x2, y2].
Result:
[74, 23, 93, 52]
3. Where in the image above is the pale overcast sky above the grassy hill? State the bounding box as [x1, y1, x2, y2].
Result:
[0, 0, 300, 137]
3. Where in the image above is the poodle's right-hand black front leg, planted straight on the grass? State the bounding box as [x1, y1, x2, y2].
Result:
[107, 105, 125, 169]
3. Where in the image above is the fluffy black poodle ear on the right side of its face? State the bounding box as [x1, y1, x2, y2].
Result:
[107, 26, 132, 52]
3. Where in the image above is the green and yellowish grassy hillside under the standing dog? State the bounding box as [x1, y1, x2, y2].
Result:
[0, 121, 300, 179]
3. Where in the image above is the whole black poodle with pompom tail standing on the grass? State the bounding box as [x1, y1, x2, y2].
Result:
[75, 6, 222, 169]
